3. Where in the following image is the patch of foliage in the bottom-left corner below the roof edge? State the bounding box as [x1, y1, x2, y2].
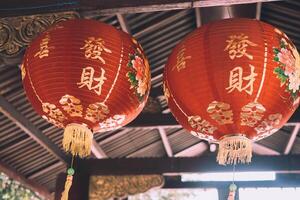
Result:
[0, 173, 40, 200]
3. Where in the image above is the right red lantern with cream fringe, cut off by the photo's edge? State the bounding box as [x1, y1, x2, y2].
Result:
[164, 19, 300, 164]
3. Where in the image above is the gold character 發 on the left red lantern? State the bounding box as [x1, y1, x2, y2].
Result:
[80, 37, 111, 64]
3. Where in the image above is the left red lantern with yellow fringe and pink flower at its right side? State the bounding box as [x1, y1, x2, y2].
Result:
[22, 19, 150, 157]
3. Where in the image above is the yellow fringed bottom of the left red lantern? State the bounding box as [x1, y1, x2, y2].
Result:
[63, 123, 93, 157]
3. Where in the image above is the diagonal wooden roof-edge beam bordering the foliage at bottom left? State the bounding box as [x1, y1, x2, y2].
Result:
[0, 161, 52, 200]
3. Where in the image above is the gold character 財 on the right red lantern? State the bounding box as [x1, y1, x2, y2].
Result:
[226, 65, 257, 95]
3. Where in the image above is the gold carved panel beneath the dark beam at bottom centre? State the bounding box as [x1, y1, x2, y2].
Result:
[89, 175, 164, 200]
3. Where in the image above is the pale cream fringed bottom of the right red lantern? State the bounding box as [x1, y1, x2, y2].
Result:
[217, 135, 252, 165]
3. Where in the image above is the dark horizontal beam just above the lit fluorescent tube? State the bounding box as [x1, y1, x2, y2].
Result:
[80, 155, 300, 175]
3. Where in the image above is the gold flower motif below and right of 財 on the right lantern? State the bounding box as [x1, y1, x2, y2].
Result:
[241, 102, 266, 127]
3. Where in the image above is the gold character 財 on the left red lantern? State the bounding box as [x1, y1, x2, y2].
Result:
[77, 67, 107, 95]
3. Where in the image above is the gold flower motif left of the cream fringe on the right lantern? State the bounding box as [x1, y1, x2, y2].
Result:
[188, 115, 217, 134]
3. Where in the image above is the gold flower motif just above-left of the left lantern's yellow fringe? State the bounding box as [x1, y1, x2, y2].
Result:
[59, 94, 83, 117]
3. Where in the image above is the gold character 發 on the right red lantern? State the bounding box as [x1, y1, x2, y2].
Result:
[224, 33, 257, 60]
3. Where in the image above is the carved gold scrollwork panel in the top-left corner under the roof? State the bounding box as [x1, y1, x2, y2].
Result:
[0, 12, 79, 57]
